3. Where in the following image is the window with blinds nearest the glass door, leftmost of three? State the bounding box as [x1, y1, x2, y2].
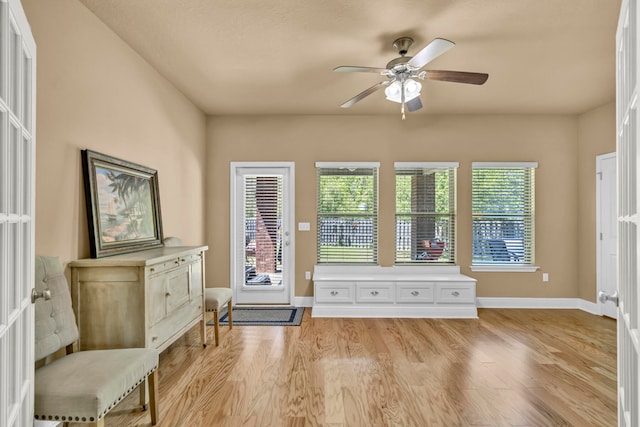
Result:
[316, 162, 379, 264]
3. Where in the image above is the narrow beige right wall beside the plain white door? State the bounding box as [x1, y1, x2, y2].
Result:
[577, 102, 616, 302]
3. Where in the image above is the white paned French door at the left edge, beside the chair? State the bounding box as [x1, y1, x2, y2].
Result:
[0, 0, 36, 427]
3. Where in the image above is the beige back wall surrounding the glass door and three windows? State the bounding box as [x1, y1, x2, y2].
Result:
[207, 115, 578, 297]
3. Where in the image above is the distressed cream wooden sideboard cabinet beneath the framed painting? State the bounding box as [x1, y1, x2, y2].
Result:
[69, 246, 208, 351]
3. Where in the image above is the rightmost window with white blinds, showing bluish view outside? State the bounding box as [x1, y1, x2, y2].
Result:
[471, 163, 538, 266]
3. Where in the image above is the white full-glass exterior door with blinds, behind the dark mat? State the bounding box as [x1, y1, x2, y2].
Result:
[230, 163, 294, 305]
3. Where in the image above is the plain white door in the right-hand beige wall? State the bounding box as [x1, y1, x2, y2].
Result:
[596, 153, 618, 319]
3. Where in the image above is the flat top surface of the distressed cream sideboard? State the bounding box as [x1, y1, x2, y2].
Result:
[69, 246, 209, 267]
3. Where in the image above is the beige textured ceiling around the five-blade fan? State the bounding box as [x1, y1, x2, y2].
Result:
[80, 0, 620, 114]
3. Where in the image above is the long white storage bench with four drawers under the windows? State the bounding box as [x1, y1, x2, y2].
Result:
[311, 265, 478, 318]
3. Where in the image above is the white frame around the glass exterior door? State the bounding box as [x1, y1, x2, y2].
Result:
[229, 162, 295, 305]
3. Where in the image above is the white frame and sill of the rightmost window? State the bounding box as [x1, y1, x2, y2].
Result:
[470, 162, 539, 272]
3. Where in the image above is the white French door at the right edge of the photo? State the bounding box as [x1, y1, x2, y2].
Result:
[614, 0, 640, 427]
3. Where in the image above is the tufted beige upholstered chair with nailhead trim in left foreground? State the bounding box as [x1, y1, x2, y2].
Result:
[34, 256, 158, 427]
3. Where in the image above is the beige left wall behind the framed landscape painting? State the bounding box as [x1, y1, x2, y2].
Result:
[22, 0, 206, 262]
